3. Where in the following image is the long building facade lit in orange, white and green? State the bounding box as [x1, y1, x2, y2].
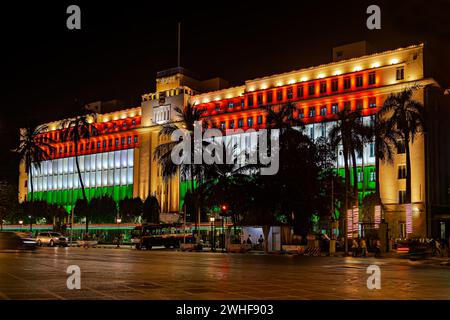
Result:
[19, 44, 450, 238]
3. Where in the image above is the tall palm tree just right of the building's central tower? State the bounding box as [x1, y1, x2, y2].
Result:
[154, 103, 202, 229]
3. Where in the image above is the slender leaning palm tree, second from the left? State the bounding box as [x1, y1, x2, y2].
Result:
[60, 113, 96, 234]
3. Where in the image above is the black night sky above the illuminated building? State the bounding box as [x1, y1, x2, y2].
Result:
[0, 0, 450, 179]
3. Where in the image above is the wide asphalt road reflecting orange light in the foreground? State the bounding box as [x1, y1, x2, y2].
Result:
[0, 248, 450, 300]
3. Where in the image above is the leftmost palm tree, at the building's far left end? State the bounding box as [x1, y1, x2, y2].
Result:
[13, 125, 55, 229]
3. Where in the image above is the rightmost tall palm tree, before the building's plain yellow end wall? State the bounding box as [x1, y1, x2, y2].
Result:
[379, 87, 425, 203]
